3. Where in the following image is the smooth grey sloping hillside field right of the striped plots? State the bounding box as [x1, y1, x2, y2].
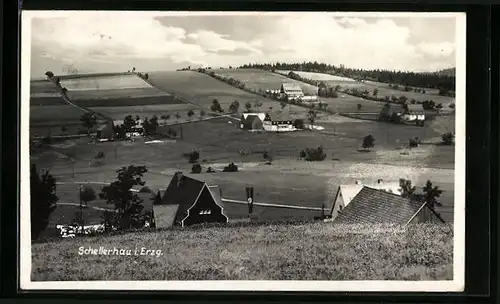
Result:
[149, 71, 307, 118]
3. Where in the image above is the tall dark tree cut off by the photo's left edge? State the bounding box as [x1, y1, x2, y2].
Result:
[30, 165, 59, 240]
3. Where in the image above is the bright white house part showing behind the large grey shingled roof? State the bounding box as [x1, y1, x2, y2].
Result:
[330, 180, 401, 220]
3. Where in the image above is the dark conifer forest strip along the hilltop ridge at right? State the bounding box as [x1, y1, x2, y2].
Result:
[238, 61, 455, 93]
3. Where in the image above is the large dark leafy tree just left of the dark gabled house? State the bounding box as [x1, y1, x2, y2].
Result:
[99, 165, 148, 230]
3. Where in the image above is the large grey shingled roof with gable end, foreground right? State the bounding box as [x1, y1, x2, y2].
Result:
[333, 186, 445, 225]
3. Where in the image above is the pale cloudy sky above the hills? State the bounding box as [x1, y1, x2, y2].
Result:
[26, 11, 456, 78]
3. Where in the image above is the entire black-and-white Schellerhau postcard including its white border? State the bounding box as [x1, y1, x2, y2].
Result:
[20, 11, 466, 292]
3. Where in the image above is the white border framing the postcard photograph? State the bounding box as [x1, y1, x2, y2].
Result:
[19, 11, 466, 292]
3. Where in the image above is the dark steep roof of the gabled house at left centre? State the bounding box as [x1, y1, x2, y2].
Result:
[161, 172, 222, 222]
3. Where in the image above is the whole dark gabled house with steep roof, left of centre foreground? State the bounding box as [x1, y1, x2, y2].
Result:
[153, 172, 229, 228]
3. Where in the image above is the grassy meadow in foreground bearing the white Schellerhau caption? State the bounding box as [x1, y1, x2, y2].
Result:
[31, 223, 453, 281]
